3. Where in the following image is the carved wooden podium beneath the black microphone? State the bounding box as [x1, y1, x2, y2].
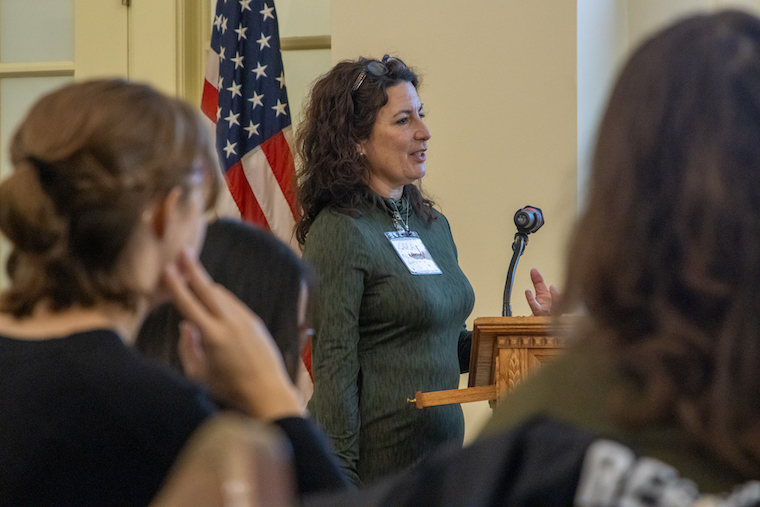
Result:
[410, 317, 572, 408]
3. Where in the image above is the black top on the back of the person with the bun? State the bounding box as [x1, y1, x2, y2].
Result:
[0, 330, 216, 506]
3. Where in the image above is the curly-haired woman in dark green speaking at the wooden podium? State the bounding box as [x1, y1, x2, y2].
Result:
[297, 56, 475, 484]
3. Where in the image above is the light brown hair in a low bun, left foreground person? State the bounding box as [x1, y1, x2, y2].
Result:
[0, 79, 220, 317]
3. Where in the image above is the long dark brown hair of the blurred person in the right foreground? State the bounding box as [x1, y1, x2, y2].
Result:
[566, 11, 760, 476]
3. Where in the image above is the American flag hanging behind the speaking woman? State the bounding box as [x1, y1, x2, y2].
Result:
[201, 0, 299, 247]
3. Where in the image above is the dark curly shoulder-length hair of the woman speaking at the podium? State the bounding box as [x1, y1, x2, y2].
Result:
[296, 55, 434, 245]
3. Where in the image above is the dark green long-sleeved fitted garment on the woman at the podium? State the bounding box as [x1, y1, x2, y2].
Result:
[303, 196, 475, 483]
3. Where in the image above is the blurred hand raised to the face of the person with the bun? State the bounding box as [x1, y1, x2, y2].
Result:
[165, 253, 302, 420]
